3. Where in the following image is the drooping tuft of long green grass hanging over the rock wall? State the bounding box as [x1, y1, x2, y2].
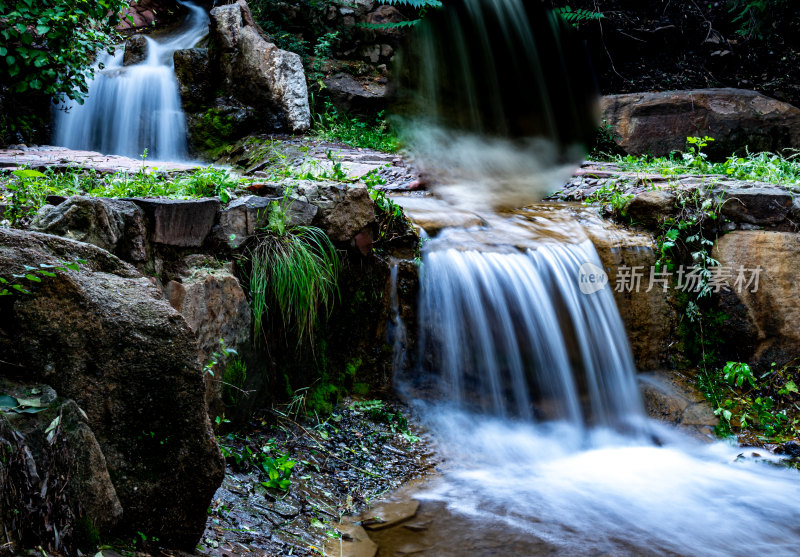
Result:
[250, 200, 340, 347]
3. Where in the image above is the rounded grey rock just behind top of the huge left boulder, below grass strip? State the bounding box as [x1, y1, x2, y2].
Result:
[30, 196, 148, 262]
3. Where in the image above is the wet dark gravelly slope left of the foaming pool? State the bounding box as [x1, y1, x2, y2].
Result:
[198, 401, 436, 555]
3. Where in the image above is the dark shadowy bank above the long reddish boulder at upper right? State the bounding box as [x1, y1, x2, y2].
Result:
[546, 0, 800, 106]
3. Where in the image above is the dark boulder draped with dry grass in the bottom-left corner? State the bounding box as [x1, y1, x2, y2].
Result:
[0, 378, 123, 554]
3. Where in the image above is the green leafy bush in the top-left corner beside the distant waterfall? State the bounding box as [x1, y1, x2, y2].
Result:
[0, 0, 128, 101]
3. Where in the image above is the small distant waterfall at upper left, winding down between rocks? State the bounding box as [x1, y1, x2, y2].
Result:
[54, 1, 209, 161]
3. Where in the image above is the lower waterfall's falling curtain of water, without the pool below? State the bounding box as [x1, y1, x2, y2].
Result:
[420, 240, 643, 427]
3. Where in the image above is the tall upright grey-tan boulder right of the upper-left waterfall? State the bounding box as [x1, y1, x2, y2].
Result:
[211, 0, 311, 132]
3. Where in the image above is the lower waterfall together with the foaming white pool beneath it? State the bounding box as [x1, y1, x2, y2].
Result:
[410, 230, 800, 556]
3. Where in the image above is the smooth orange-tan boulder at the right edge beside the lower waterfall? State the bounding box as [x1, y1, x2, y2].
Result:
[712, 230, 800, 369]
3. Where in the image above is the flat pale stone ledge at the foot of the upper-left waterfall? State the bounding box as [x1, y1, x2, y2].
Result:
[0, 145, 199, 174]
